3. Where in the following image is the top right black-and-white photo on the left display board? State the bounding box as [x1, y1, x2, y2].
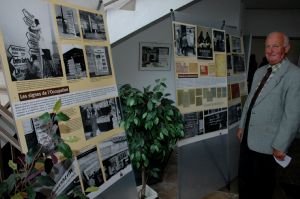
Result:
[79, 10, 107, 41]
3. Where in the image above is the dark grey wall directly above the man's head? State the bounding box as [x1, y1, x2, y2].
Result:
[243, 9, 300, 37]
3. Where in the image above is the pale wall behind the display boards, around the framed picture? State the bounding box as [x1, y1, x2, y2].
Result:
[112, 0, 240, 100]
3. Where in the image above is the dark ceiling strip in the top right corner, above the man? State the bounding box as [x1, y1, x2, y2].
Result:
[242, 0, 300, 9]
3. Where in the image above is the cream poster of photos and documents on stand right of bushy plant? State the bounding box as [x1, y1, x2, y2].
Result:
[173, 22, 233, 141]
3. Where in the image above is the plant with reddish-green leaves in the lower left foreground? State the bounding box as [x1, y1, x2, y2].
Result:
[0, 100, 84, 199]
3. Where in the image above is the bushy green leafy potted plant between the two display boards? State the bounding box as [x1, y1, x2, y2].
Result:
[119, 79, 184, 199]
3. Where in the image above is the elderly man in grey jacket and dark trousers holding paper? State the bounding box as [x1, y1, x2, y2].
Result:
[237, 32, 300, 199]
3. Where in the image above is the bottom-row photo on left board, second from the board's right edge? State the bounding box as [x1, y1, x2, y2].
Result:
[77, 147, 104, 190]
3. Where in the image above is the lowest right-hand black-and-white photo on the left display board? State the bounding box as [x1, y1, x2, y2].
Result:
[99, 133, 130, 180]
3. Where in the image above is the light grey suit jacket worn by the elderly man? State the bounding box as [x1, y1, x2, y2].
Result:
[239, 59, 300, 154]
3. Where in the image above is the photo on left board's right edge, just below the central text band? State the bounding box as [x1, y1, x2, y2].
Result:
[80, 98, 121, 140]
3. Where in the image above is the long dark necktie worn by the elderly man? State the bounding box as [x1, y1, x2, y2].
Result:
[242, 67, 272, 142]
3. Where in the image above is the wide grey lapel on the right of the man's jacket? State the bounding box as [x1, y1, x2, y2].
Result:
[255, 60, 289, 105]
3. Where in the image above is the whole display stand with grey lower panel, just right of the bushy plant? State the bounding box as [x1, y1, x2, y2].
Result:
[170, 10, 240, 199]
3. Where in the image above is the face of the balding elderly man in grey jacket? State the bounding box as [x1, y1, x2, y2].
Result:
[265, 33, 289, 65]
